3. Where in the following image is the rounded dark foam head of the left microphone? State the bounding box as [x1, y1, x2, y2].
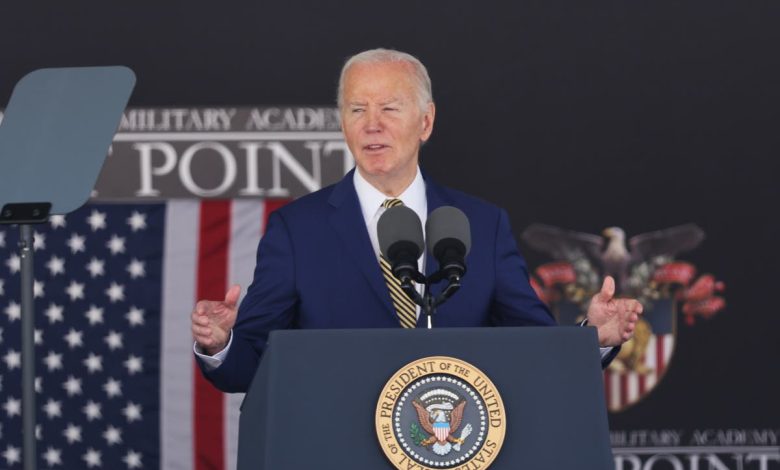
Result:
[376, 206, 425, 263]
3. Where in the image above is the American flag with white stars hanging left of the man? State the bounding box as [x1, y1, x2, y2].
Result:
[0, 200, 283, 470]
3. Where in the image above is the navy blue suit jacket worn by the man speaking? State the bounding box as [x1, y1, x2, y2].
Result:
[202, 170, 555, 392]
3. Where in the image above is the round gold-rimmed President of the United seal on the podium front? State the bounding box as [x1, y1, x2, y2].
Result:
[375, 356, 506, 470]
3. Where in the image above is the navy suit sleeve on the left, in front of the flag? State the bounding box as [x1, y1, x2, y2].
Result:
[198, 211, 298, 392]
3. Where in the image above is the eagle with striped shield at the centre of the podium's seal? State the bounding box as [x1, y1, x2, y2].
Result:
[412, 389, 472, 455]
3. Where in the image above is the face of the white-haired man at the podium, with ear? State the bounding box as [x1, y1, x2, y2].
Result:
[341, 62, 434, 191]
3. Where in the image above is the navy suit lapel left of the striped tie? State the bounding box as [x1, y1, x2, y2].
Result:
[328, 169, 396, 318]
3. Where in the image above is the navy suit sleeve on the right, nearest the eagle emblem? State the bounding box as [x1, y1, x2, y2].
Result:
[492, 209, 555, 326]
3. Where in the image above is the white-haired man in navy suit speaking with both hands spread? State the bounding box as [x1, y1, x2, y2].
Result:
[192, 49, 642, 392]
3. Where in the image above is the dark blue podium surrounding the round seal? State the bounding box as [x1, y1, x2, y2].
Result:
[238, 327, 614, 470]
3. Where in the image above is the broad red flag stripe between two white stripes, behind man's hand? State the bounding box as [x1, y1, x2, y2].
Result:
[193, 201, 230, 470]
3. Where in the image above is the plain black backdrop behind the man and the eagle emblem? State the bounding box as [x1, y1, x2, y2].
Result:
[0, 0, 780, 469]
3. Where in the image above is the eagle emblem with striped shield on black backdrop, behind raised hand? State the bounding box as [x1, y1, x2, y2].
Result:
[521, 224, 726, 412]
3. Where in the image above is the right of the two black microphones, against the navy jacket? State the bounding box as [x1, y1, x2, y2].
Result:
[425, 206, 471, 283]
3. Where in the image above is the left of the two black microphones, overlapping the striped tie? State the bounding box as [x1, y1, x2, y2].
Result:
[376, 206, 425, 284]
